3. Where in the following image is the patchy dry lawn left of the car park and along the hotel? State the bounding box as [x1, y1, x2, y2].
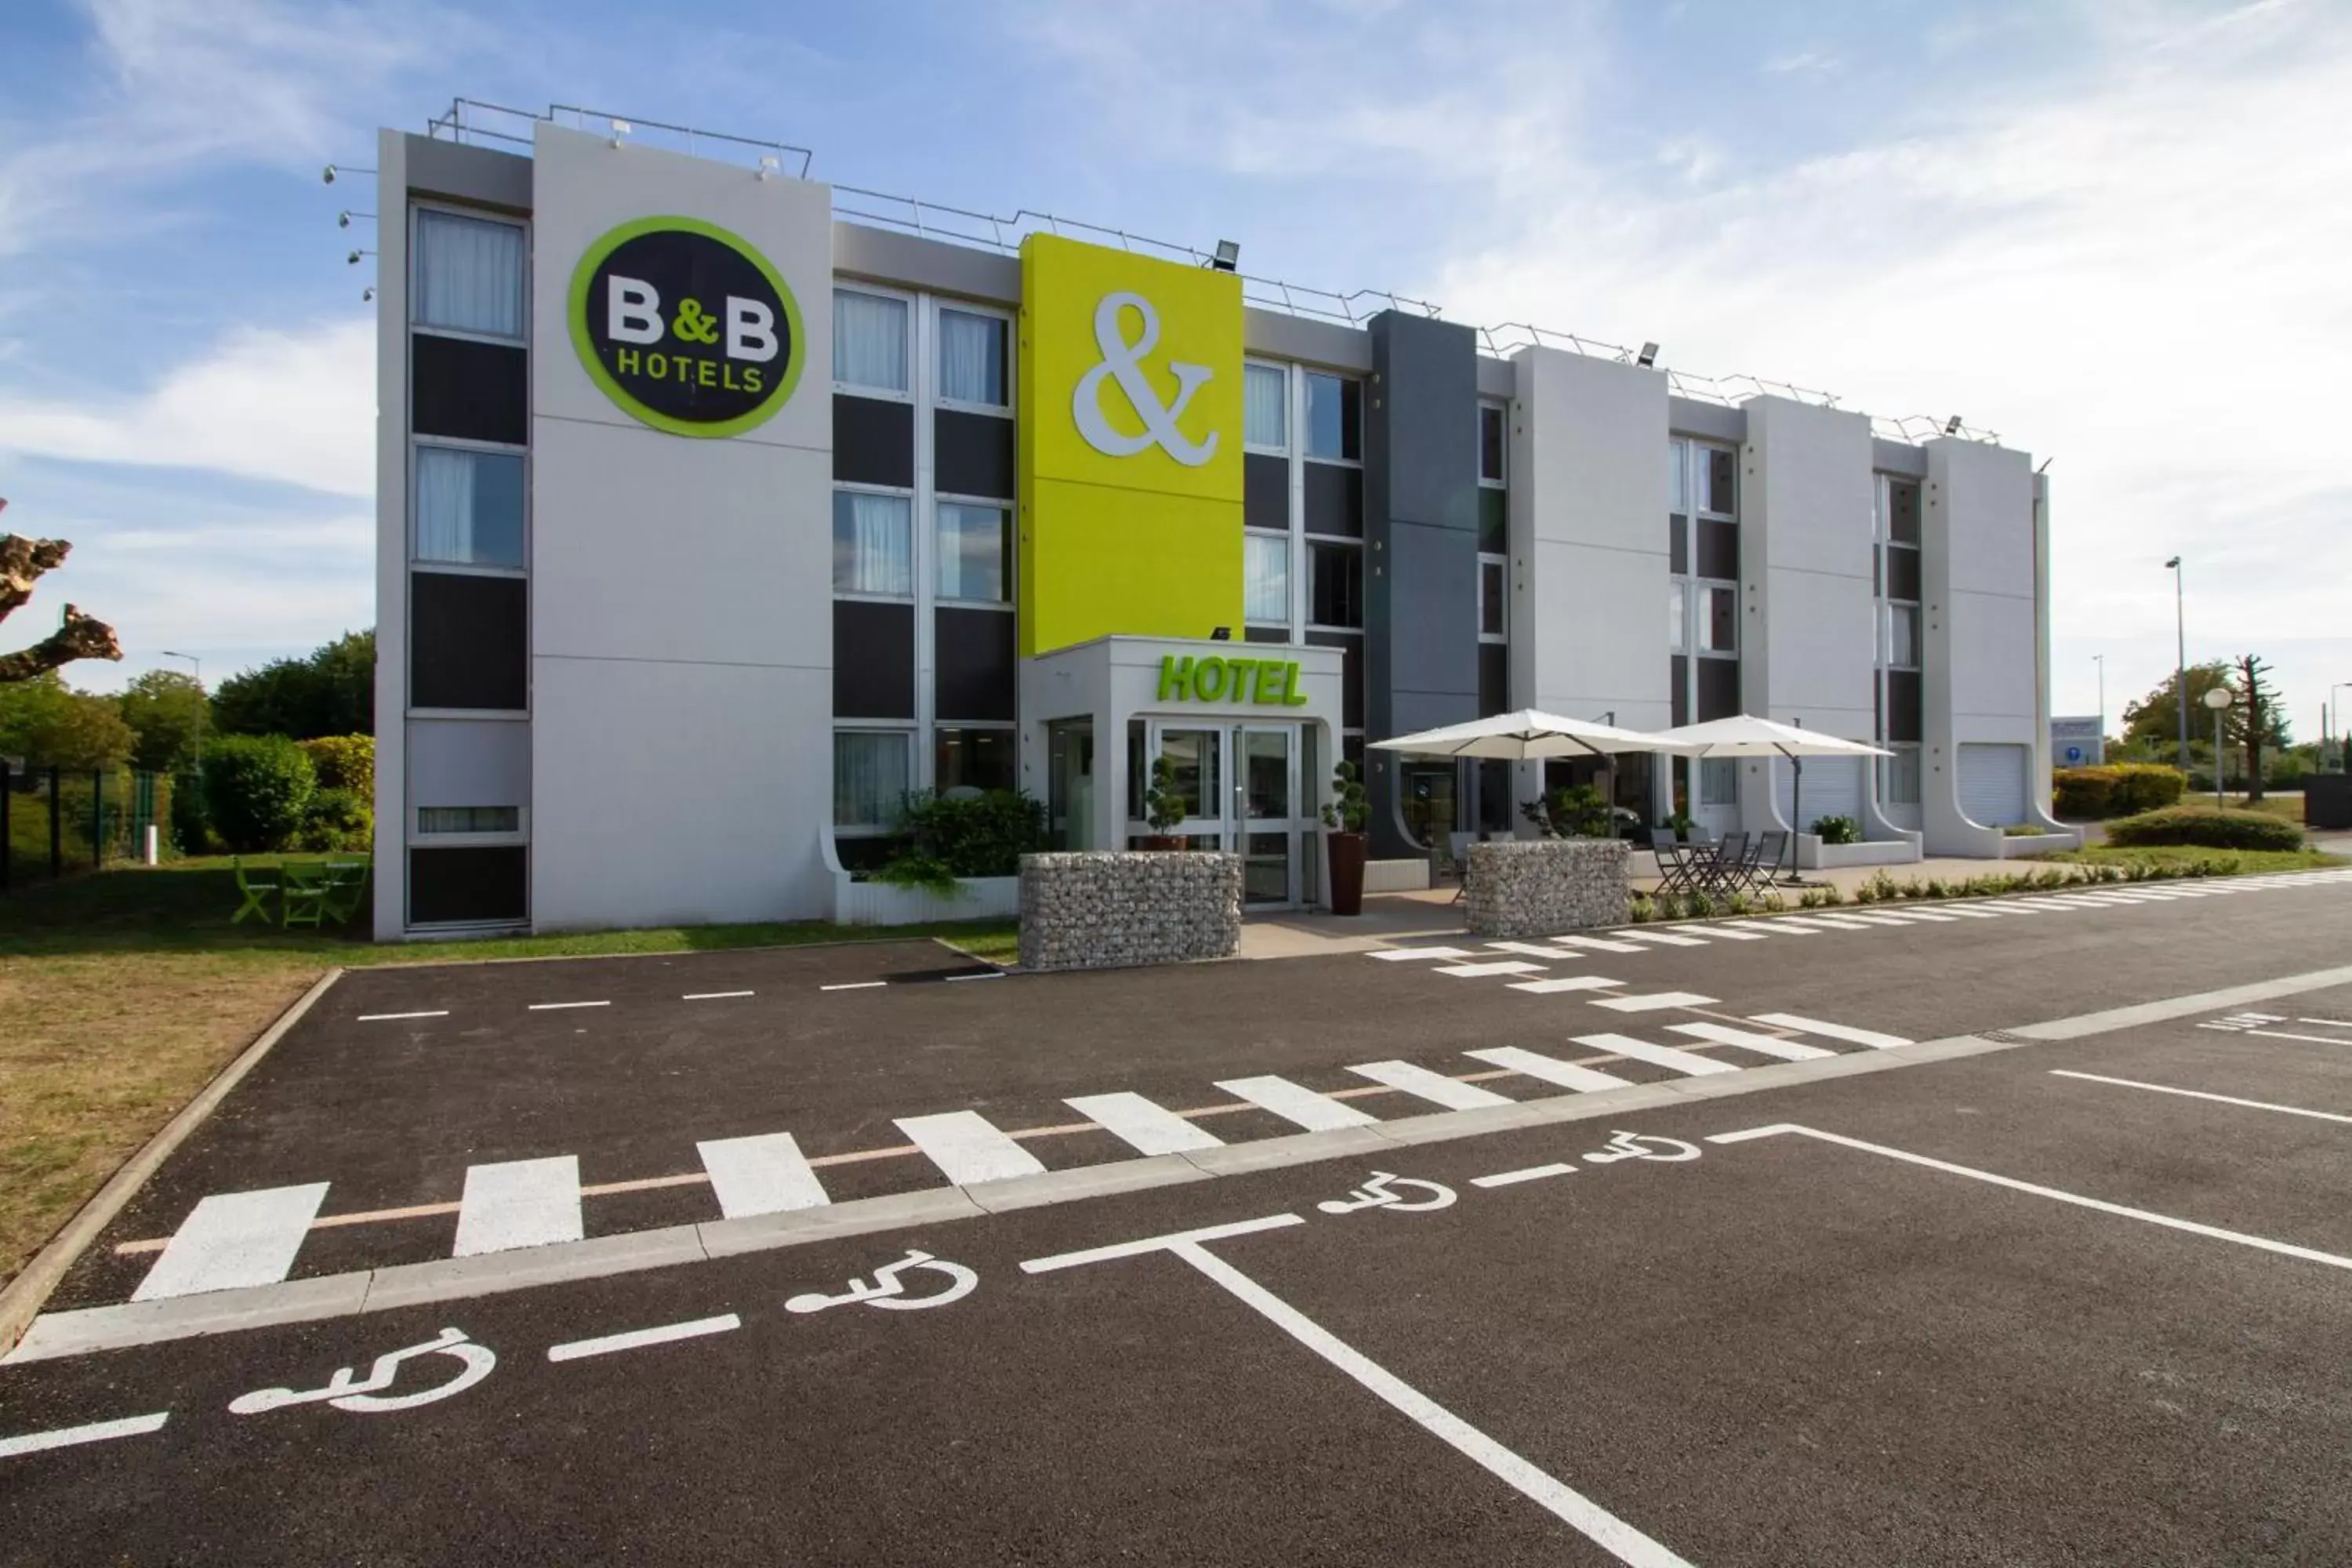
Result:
[0, 855, 1018, 1283]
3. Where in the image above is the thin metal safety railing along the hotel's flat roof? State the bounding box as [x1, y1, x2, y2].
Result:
[405, 99, 2002, 447]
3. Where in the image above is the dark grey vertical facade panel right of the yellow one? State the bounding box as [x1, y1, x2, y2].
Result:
[1364, 310, 1479, 855]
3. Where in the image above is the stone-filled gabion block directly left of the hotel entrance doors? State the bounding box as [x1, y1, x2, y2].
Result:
[1021, 851, 1242, 968]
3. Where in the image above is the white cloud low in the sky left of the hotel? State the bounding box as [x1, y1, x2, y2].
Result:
[0, 320, 376, 496]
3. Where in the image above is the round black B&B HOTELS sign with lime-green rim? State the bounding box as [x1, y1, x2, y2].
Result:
[569, 219, 804, 435]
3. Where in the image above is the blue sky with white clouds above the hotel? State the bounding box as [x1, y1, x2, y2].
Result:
[0, 0, 2352, 739]
